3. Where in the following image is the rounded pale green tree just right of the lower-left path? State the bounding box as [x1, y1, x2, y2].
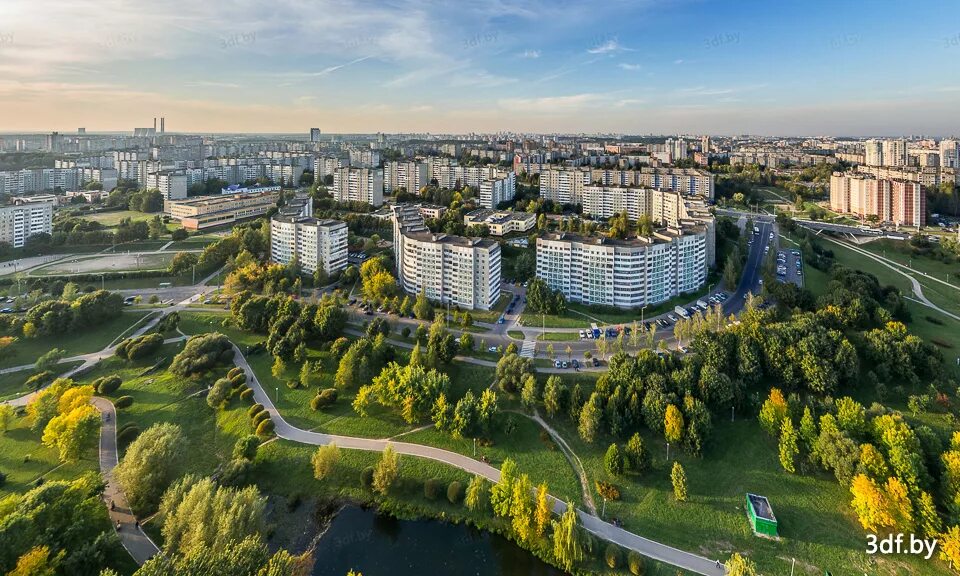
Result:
[113, 423, 185, 510]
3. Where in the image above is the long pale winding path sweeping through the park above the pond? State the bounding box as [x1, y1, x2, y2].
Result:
[233, 345, 724, 576]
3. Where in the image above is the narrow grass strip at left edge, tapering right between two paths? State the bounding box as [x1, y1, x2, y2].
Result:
[0, 312, 146, 368]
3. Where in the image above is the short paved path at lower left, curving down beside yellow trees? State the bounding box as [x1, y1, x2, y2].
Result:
[90, 397, 160, 564]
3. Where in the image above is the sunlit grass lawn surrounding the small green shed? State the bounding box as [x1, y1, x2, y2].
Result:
[555, 417, 947, 575]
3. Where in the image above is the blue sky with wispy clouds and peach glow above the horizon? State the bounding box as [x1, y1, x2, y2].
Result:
[0, 0, 960, 136]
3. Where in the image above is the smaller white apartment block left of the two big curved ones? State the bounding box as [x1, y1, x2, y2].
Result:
[270, 215, 347, 274]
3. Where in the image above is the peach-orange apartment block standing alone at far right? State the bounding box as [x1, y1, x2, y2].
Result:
[830, 172, 927, 226]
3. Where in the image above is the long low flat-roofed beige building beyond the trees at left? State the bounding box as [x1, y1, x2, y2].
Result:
[163, 191, 280, 230]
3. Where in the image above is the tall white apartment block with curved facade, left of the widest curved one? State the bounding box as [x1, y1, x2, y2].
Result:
[392, 204, 500, 310]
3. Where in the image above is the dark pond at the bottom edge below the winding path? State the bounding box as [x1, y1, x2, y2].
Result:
[313, 506, 565, 576]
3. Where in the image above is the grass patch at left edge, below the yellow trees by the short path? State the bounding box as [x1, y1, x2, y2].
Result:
[0, 408, 98, 497]
